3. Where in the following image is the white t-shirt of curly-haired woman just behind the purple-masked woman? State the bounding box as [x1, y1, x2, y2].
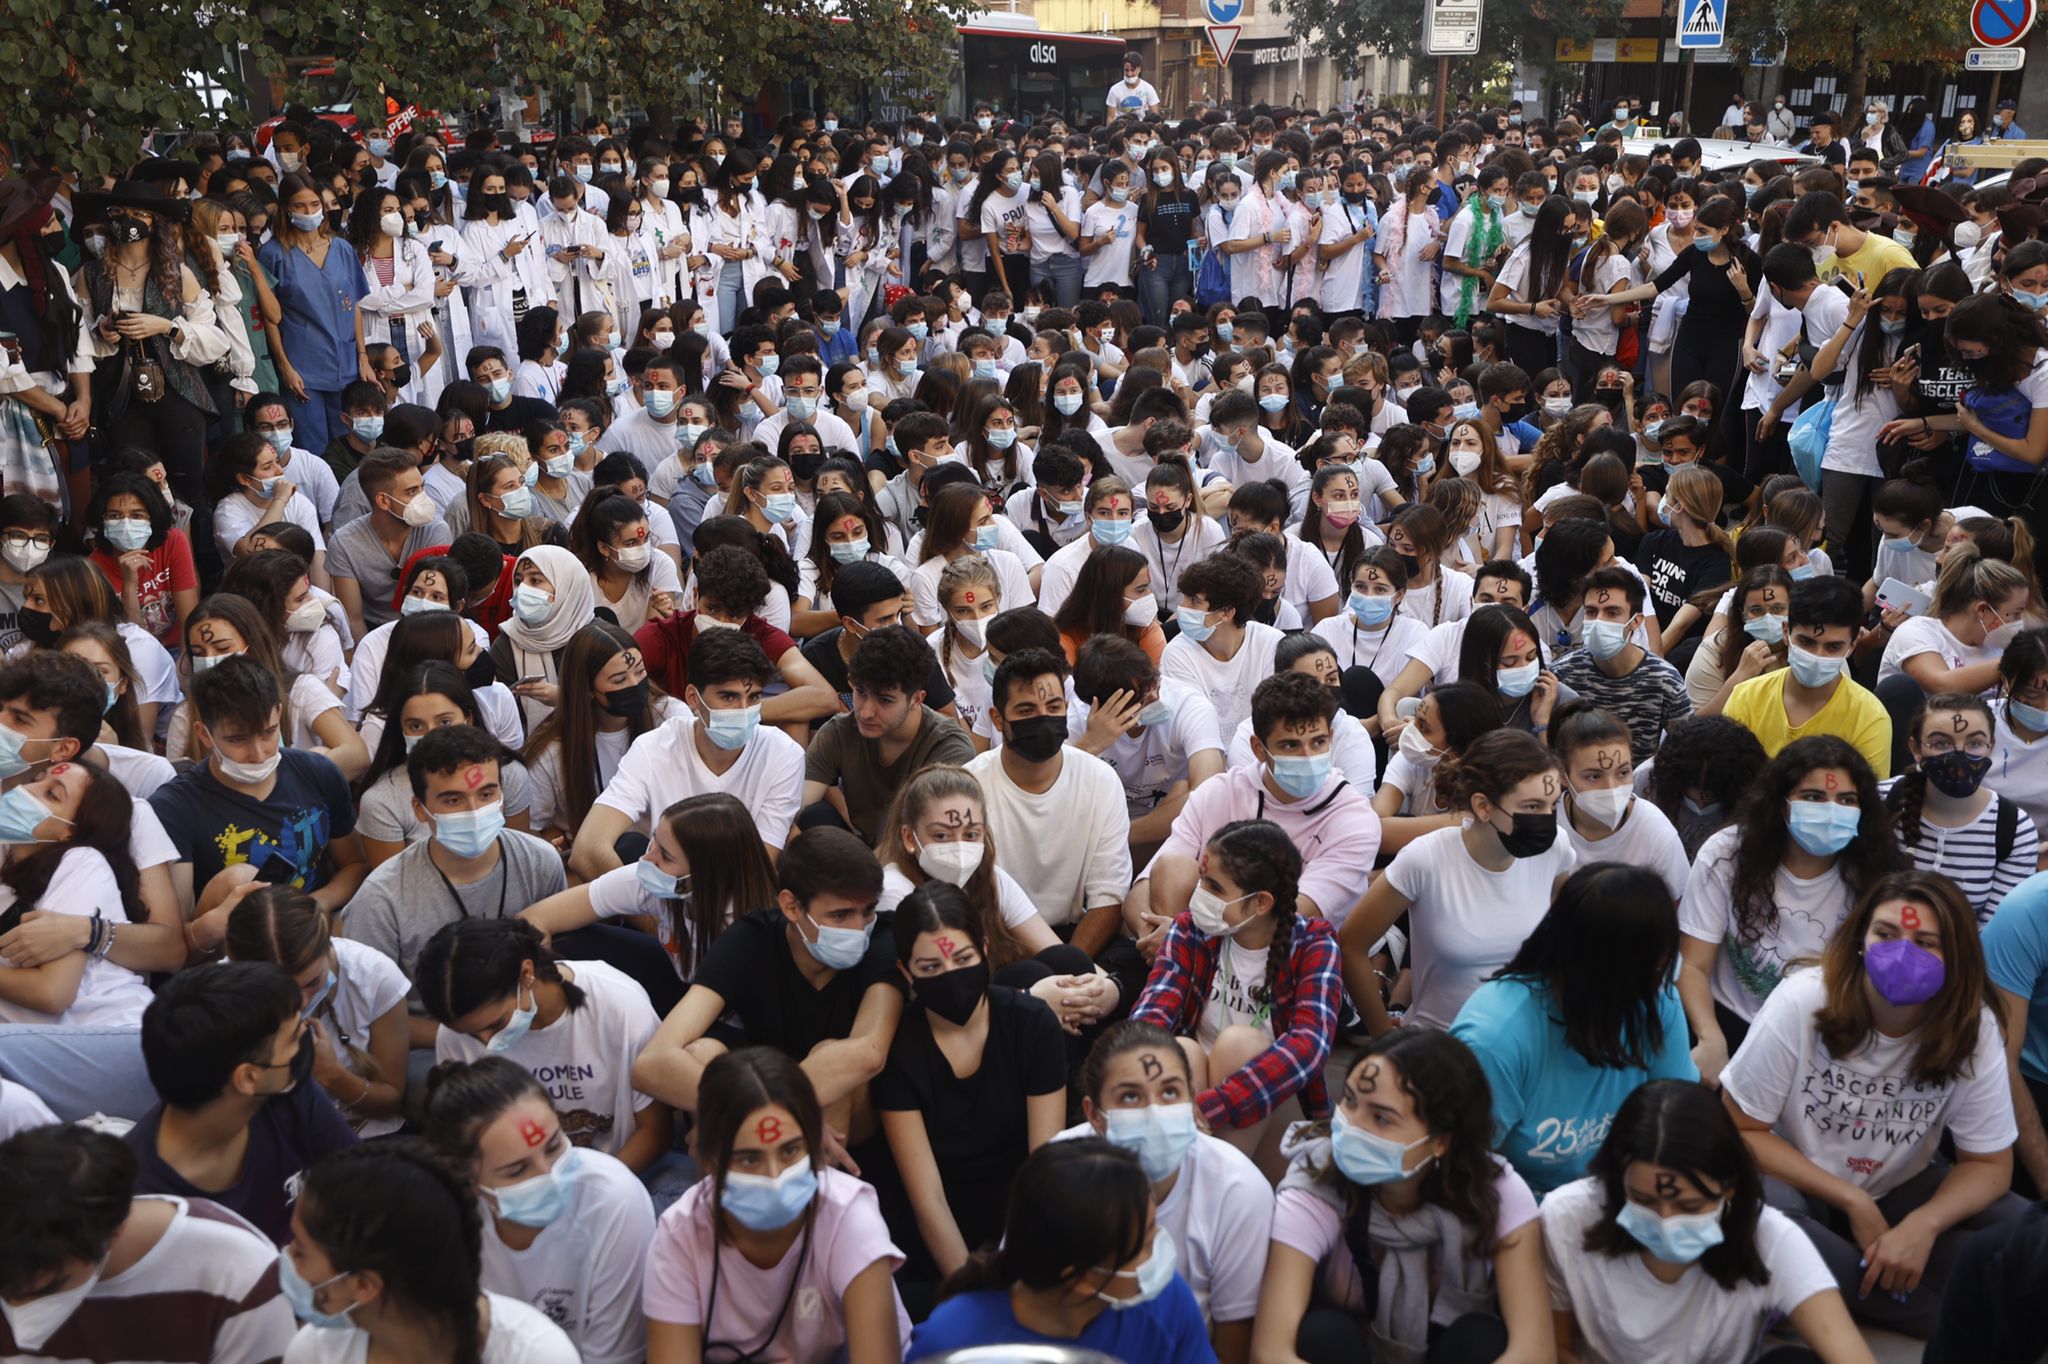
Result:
[1677, 825, 1849, 1018]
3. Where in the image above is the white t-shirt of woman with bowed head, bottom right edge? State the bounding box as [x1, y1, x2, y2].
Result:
[1540, 1178, 1835, 1364]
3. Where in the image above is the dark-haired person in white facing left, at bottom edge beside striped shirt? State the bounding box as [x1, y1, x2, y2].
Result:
[276, 1137, 580, 1364]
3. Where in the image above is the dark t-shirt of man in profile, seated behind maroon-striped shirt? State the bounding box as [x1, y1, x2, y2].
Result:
[127, 1073, 358, 1245]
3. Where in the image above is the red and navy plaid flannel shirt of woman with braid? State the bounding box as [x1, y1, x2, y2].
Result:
[1130, 913, 1343, 1126]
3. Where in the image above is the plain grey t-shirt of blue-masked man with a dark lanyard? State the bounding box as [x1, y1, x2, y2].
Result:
[342, 829, 569, 1012]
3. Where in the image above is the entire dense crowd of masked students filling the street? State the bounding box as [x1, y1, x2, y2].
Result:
[0, 69, 2048, 1364]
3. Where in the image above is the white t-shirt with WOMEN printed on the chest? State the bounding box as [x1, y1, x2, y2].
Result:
[434, 961, 662, 1155]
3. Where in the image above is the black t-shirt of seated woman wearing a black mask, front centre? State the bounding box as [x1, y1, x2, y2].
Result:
[874, 985, 1067, 1245]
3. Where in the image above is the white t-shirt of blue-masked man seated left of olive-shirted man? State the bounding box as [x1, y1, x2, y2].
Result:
[589, 709, 803, 848]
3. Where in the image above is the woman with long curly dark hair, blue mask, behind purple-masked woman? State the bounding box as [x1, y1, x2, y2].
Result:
[1677, 737, 1903, 1085]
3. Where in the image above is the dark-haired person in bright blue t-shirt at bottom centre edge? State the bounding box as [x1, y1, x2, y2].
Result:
[905, 1137, 1217, 1364]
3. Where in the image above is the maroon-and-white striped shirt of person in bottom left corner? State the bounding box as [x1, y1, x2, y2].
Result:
[0, 1194, 299, 1364]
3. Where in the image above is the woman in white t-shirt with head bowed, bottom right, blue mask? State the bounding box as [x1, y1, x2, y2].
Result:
[1542, 1079, 1872, 1364]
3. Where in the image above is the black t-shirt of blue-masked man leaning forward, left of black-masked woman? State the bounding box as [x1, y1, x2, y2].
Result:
[690, 909, 903, 1061]
